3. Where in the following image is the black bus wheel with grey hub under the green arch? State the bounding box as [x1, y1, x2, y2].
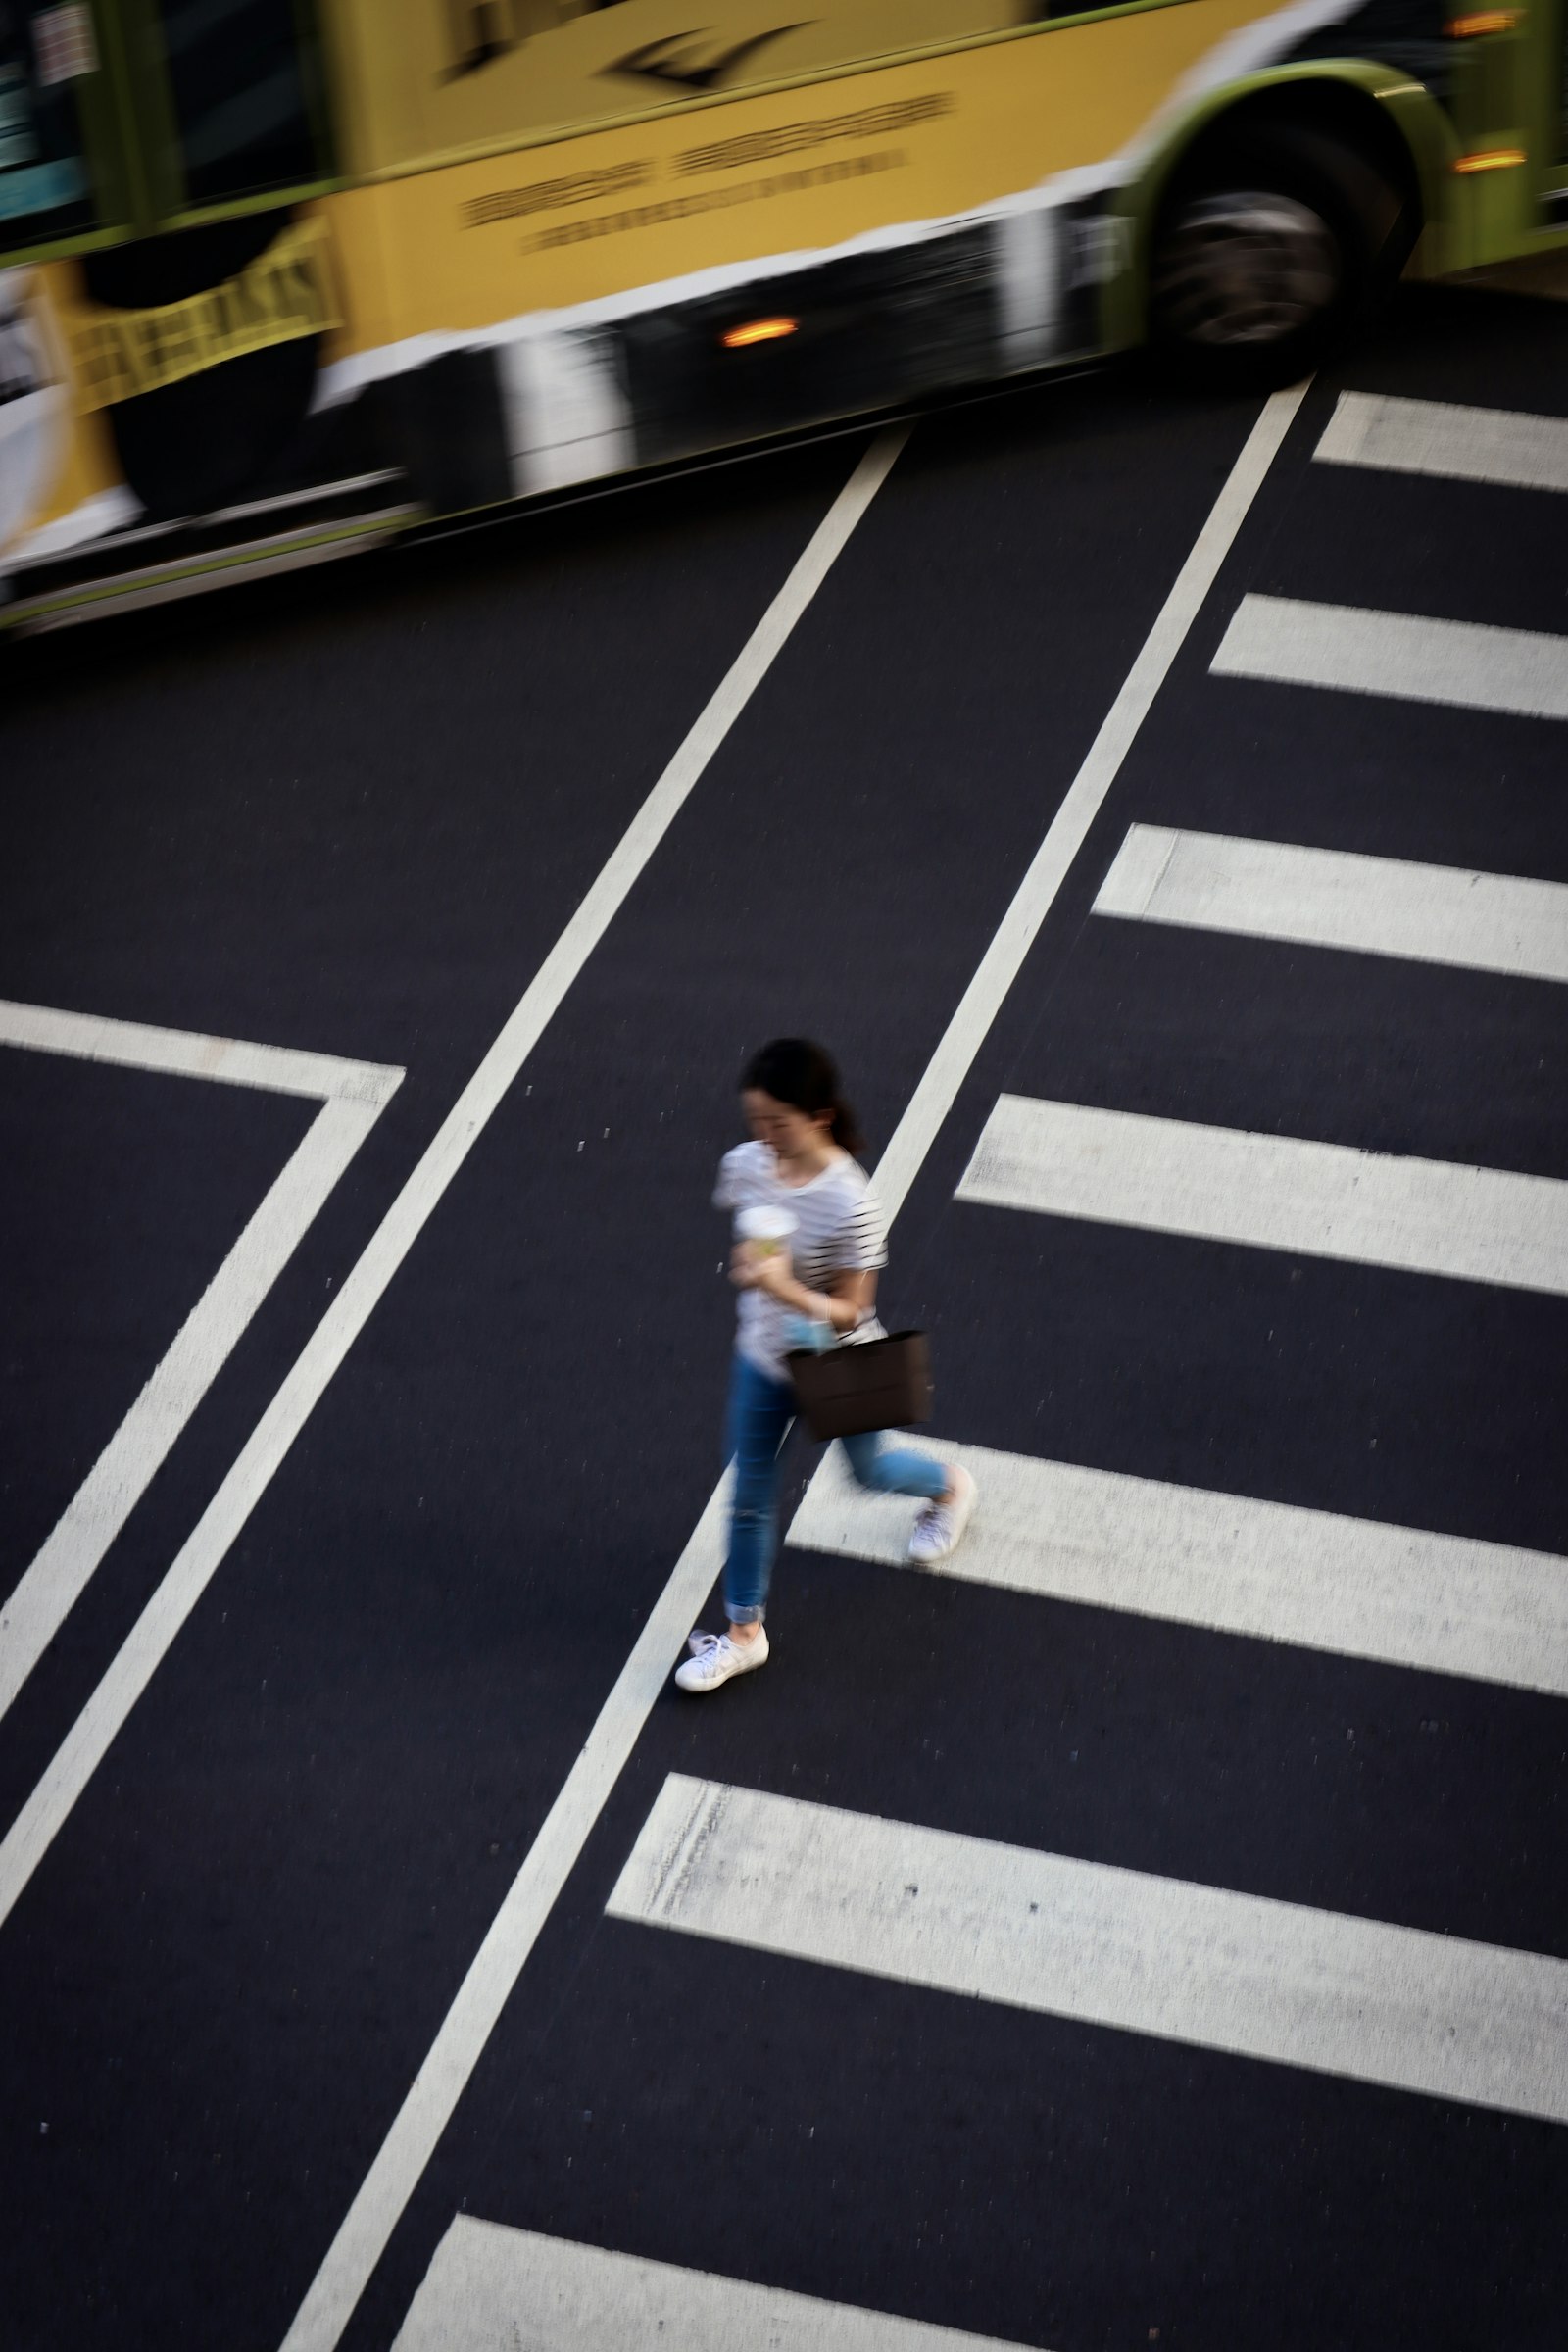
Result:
[1150, 120, 1417, 390]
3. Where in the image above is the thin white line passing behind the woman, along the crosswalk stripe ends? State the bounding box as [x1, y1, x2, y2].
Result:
[275, 386, 1307, 2352]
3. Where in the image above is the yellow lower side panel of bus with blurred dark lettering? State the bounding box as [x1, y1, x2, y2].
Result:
[373, 0, 1257, 331]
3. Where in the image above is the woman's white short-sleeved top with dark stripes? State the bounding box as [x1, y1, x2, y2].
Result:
[712, 1143, 886, 1381]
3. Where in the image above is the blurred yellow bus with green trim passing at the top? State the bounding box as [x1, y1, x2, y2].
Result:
[0, 0, 1568, 630]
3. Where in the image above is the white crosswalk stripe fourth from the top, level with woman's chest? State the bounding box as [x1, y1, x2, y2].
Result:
[956, 1094, 1568, 1296]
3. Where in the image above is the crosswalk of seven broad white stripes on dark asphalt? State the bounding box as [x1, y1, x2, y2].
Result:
[397, 393, 1568, 2352]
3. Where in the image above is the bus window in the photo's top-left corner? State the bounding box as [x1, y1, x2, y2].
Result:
[0, 0, 96, 247]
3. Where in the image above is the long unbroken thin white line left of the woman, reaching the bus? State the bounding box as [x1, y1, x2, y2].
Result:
[0, 428, 907, 1924]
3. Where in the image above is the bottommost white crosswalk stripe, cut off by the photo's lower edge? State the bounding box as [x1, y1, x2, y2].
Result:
[393, 2213, 1044, 2352]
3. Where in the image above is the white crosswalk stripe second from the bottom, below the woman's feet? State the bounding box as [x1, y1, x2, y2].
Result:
[607, 1774, 1568, 2124]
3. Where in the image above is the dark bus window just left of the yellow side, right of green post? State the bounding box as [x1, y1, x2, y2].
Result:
[151, 0, 329, 205]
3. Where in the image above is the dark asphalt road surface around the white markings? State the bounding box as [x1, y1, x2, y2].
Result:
[0, 292, 1568, 2352]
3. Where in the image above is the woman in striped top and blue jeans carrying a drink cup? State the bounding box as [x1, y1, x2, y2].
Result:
[674, 1037, 976, 1691]
